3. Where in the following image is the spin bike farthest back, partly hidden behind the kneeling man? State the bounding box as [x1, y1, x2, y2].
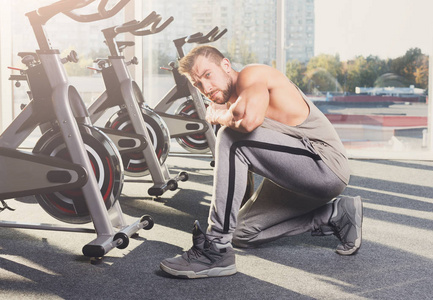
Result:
[153, 27, 227, 157]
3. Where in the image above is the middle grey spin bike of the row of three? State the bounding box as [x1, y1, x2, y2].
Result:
[88, 12, 188, 197]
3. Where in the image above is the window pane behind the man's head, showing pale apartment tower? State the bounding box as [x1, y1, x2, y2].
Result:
[137, 0, 276, 106]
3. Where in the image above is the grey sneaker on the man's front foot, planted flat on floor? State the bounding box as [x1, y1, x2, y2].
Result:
[160, 221, 236, 278]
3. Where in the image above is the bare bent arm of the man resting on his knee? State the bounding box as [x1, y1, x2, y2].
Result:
[206, 66, 269, 132]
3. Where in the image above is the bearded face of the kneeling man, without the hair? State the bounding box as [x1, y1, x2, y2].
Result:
[190, 56, 233, 104]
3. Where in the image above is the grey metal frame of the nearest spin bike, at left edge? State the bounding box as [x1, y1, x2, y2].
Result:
[0, 0, 150, 257]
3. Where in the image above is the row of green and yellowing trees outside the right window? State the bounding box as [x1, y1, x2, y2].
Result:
[300, 48, 429, 92]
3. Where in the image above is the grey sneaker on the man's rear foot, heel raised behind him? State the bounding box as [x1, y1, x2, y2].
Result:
[329, 196, 362, 255]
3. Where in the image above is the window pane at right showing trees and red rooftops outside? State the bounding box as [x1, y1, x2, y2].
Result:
[310, 0, 433, 158]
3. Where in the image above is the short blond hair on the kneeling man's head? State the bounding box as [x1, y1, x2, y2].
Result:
[179, 45, 224, 77]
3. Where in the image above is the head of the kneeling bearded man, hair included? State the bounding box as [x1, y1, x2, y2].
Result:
[179, 46, 234, 104]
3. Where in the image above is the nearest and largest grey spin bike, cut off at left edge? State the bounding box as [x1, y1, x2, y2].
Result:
[0, 0, 153, 258]
